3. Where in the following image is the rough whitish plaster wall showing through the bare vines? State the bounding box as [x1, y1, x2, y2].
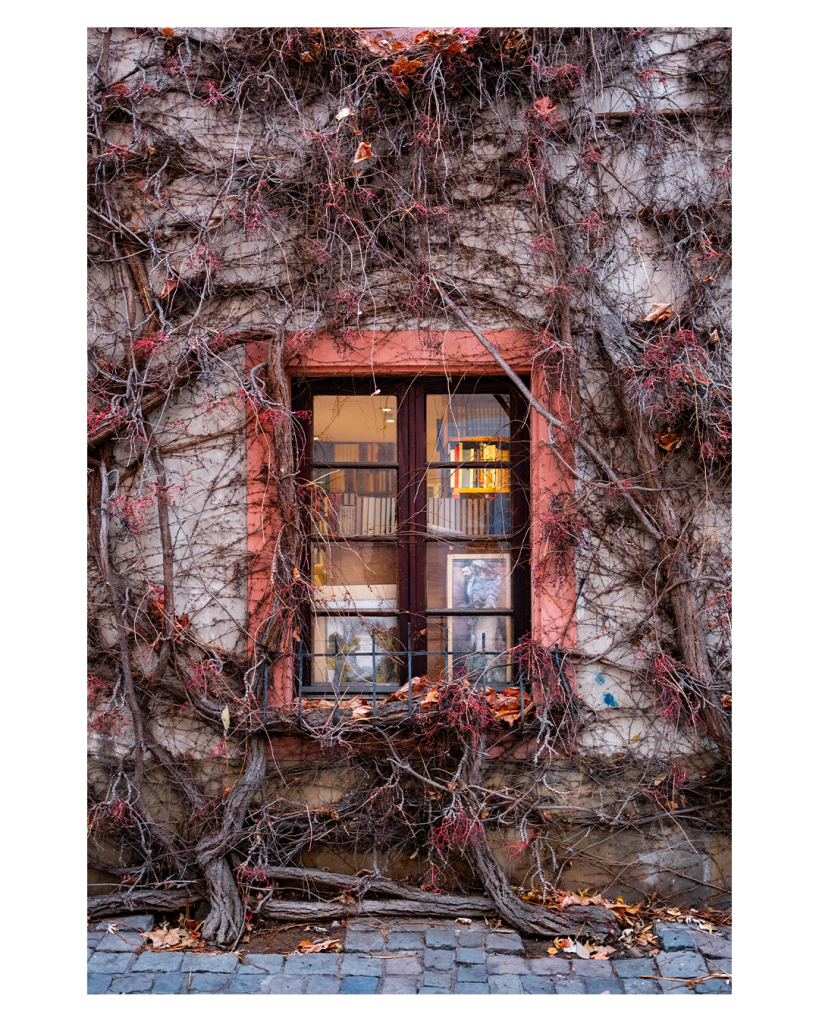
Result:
[90, 29, 730, 770]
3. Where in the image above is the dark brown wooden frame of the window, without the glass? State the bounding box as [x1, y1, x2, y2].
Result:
[292, 373, 531, 689]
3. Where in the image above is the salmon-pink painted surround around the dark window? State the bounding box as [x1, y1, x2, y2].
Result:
[246, 331, 575, 703]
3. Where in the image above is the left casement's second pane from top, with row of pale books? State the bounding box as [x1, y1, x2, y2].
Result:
[313, 469, 398, 537]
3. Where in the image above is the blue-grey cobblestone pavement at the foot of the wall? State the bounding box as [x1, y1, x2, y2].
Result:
[88, 916, 731, 995]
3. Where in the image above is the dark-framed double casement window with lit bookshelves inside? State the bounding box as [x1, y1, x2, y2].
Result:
[293, 377, 529, 695]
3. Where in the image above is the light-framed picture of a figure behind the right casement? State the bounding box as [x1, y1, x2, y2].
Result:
[446, 552, 512, 688]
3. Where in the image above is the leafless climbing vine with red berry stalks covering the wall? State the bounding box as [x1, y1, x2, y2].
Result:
[88, 28, 731, 943]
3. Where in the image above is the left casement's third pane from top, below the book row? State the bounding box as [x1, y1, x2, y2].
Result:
[312, 542, 398, 611]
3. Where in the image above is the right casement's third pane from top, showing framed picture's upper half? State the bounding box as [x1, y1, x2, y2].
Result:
[427, 542, 512, 609]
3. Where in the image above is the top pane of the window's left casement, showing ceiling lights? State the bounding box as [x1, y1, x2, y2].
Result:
[313, 394, 398, 462]
